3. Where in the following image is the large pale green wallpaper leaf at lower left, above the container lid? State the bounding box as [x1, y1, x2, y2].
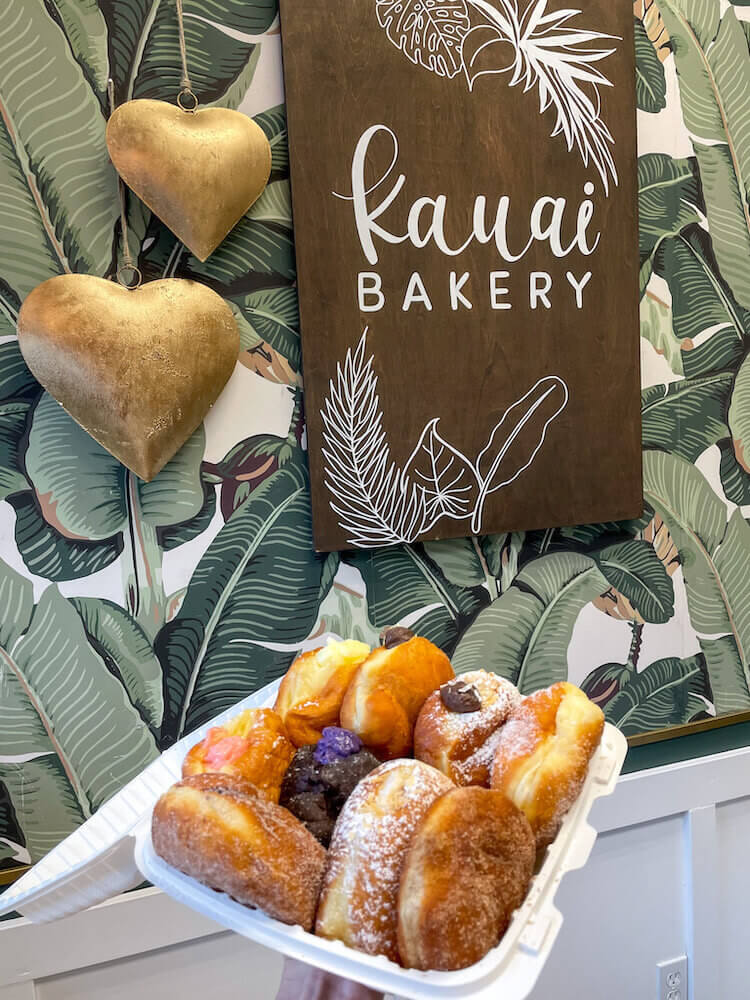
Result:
[0, 563, 158, 860]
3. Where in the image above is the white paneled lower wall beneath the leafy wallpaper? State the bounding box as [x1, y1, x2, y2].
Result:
[0, 749, 750, 1000]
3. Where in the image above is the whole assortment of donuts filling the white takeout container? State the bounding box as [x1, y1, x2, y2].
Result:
[152, 627, 604, 970]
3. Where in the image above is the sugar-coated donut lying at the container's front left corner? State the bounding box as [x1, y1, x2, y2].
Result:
[151, 774, 326, 931]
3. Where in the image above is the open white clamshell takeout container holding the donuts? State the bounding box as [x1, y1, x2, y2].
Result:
[0, 681, 627, 1000]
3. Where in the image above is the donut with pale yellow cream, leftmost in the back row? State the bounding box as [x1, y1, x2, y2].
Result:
[274, 639, 370, 747]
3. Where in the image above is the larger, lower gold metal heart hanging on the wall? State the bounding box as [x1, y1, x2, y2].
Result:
[18, 274, 240, 482]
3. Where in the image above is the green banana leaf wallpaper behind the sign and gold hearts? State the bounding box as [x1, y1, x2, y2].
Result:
[0, 0, 750, 868]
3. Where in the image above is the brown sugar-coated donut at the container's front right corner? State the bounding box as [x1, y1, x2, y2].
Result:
[398, 788, 536, 971]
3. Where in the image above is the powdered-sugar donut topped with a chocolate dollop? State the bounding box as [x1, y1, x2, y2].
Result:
[414, 670, 521, 786]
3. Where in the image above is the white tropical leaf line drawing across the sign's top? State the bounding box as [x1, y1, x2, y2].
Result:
[375, 0, 622, 194]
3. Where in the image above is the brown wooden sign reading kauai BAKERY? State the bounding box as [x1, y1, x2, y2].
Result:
[281, 0, 642, 550]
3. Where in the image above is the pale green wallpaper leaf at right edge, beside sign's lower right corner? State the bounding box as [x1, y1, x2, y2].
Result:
[644, 451, 750, 714]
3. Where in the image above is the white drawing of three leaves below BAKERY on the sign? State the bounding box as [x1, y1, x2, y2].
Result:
[321, 328, 569, 548]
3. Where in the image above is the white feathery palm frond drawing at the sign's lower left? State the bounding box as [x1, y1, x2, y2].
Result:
[321, 329, 427, 548]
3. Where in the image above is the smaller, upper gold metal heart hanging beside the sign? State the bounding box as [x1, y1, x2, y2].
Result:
[107, 100, 271, 260]
